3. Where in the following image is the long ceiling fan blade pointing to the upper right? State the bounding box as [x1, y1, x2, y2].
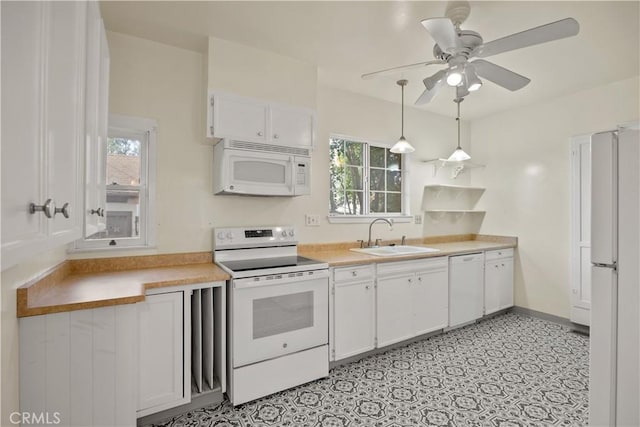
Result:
[470, 18, 580, 58]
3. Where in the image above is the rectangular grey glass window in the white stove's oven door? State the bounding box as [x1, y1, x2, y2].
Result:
[253, 291, 314, 340]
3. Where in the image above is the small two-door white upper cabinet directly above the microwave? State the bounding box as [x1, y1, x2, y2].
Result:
[207, 92, 315, 147]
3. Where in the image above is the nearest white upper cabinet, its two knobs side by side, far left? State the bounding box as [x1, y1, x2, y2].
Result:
[2, 2, 107, 269]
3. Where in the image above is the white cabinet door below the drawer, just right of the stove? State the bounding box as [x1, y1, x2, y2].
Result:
[334, 280, 375, 360]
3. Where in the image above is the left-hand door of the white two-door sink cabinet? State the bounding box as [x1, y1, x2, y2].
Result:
[377, 274, 416, 347]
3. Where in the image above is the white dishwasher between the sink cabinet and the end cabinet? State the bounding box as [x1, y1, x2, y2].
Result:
[449, 253, 484, 328]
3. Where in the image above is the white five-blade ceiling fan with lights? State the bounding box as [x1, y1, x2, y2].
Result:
[362, 1, 580, 105]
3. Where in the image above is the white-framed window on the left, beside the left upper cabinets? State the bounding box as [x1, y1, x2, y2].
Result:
[76, 115, 156, 249]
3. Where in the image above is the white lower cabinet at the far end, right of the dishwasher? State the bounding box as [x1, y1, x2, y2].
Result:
[484, 249, 513, 314]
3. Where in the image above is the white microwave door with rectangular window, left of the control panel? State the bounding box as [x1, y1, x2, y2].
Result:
[217, 148, 295, 196]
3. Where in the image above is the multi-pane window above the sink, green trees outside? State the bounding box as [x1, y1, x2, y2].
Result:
[329, 137, 408, 222]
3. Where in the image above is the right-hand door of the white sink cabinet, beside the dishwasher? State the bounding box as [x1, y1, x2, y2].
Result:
[412, 267, 449, 335]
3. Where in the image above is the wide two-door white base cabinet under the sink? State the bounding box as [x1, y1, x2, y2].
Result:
[376, 257, 449, 347]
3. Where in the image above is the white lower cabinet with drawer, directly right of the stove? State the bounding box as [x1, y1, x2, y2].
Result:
[331, 264, 375, 360]
